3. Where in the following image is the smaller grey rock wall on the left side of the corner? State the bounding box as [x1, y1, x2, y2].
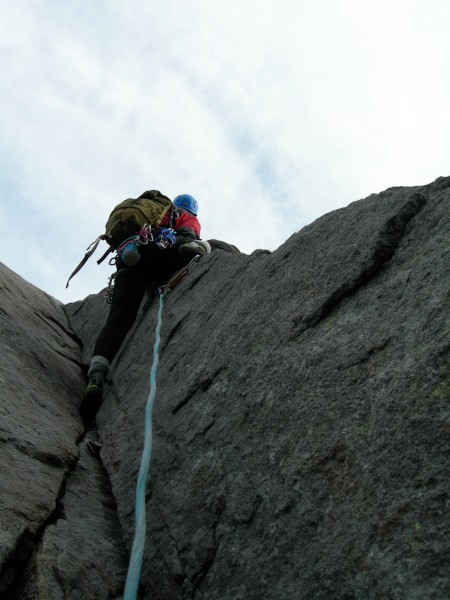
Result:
[0, 264, 127, 600]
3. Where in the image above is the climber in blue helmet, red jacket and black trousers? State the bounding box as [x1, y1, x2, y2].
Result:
[80, 194, 211, 425]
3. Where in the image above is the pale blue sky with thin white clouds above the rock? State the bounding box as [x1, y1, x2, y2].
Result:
[0, 0, 450, 303]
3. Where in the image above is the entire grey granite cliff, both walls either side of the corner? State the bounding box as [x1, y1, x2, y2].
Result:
[0, 178, 450, 600]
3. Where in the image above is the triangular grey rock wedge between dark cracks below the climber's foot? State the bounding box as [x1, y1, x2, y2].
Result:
[5, 433, 128, 600]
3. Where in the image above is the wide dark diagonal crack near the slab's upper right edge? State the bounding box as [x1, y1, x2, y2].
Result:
[291, 192, 426, 339]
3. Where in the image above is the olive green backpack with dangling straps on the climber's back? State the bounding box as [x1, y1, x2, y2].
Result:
[66, 190, 172, 288]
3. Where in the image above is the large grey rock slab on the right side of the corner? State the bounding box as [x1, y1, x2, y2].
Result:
[68, 178, 450, 600]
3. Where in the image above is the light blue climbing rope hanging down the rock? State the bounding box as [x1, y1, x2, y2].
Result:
[123, 290, 163, 600]
